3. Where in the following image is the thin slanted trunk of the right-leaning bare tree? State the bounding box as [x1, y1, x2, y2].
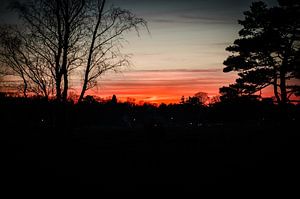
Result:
[78, 0, 105, 102]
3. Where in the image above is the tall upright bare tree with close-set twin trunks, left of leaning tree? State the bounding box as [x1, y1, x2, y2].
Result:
[12, 0, 87, 101]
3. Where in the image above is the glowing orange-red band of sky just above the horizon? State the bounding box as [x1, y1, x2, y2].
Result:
[77, 69, 236, 104]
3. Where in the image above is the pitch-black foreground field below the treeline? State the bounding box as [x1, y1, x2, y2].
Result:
[1, 124, 299, 191]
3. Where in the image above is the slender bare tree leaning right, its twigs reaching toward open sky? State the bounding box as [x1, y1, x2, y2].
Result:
[78, 0, 147, 102]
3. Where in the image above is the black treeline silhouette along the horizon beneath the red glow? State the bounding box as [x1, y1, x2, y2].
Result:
[0, 94, 300, 128]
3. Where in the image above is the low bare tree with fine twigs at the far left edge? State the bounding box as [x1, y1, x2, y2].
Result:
[0, 26, 53, 98]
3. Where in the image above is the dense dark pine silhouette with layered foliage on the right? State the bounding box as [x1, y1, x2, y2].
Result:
[220, 1, 300, 105]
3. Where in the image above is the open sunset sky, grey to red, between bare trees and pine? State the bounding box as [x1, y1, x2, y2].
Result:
[0, 0, 276, 103]
